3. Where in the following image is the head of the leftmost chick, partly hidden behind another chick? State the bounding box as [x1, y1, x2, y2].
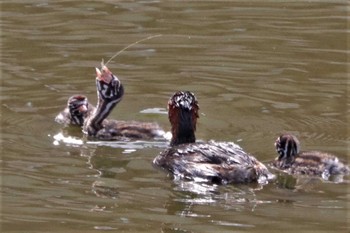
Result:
[67, 95, 89, 126]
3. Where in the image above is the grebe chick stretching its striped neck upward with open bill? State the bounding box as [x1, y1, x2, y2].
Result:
[83, 64, 164, 140]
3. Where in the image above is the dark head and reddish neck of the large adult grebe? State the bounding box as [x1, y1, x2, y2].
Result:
[168, 91, 199, 145]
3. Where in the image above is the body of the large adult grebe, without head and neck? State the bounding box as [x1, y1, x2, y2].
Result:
[153, 141, 271, 184]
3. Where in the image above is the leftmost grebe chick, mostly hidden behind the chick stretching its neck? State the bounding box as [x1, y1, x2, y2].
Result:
[55, 95, 95, 126]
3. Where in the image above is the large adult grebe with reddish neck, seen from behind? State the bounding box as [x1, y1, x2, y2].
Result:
[153, 91, 273, 184]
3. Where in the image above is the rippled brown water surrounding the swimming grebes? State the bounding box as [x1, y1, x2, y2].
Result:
[0, 0, 350, 232]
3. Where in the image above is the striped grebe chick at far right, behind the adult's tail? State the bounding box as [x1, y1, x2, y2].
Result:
[273, 134, 350, 179]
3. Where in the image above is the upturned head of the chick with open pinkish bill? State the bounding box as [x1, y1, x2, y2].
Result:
[96, 64, 124, 104]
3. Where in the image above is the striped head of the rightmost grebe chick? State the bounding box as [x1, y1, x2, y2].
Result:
[275, 134, 300, 162]
